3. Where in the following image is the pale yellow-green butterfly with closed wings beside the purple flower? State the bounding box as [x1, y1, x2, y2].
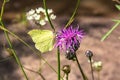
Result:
[28, 29, 53, 53]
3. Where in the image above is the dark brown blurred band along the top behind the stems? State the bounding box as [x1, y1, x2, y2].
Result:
[0, 0, 119, 20]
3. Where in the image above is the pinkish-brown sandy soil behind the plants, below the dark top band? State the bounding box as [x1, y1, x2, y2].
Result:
[0, 0, 120, 80]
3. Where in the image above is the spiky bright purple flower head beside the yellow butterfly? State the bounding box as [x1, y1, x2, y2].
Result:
[56, 25, 84, 59]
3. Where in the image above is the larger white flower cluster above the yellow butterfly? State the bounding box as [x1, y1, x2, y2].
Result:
[26, 7, 56, 26]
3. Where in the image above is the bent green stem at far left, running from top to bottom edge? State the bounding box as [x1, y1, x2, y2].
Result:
[0, 0, 28, 80]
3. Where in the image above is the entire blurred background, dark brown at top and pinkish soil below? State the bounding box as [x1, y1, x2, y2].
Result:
[0, 0, 120, 80]
